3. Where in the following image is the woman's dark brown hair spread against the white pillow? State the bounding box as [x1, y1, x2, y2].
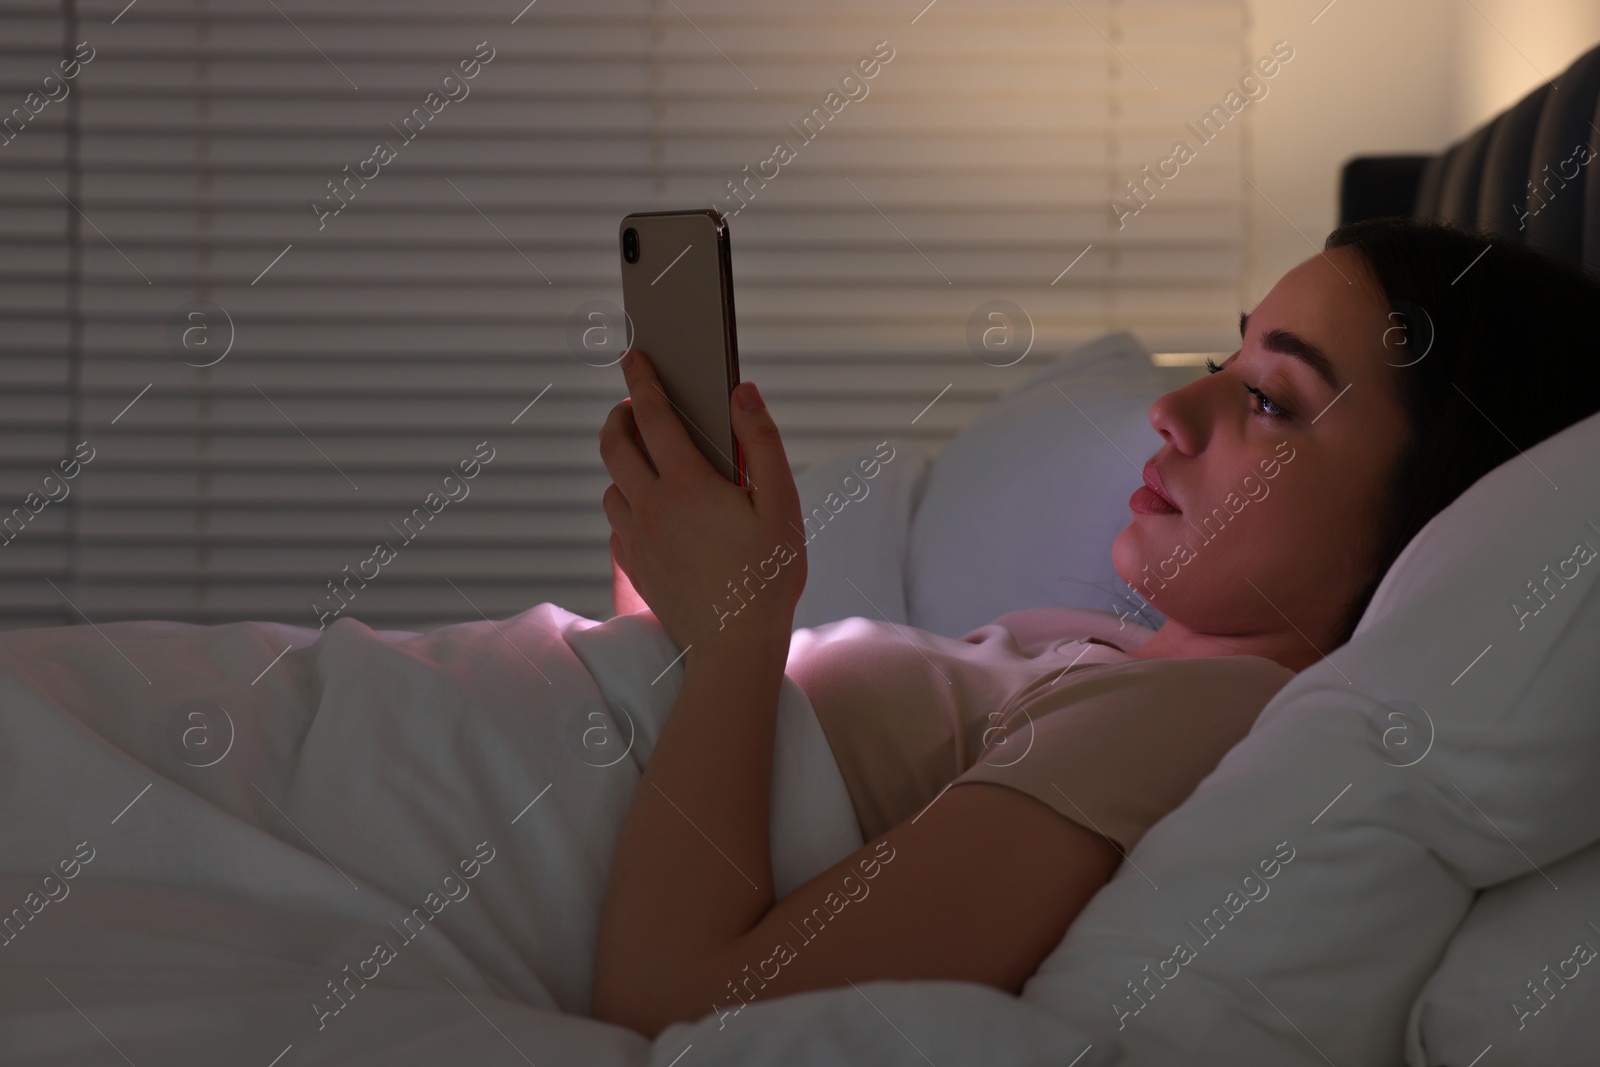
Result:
[1325, 218, 1600, 645]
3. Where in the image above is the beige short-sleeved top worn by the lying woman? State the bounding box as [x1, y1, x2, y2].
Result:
[786, 608, 1294, 853]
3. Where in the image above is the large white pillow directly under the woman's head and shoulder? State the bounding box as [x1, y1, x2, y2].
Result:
[1017, 404, 1600, 1067]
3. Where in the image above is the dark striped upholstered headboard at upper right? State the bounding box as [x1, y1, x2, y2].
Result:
[1339, 40, 1600, 272]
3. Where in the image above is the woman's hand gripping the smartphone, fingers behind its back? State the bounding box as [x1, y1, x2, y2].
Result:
[600, 352, 806, 649]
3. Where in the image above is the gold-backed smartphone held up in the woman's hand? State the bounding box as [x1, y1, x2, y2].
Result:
[618, 210, 746, 486]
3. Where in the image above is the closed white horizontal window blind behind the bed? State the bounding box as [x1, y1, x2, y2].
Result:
[0, 0, 1246, 630]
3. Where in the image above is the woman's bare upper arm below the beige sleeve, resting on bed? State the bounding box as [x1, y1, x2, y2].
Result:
[686, 782, 1122, 1017]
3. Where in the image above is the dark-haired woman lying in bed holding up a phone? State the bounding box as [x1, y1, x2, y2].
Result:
[594, 221, 1600, 1037]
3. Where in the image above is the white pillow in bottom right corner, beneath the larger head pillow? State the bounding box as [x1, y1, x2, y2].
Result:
[1405, 819, 1600, 1067]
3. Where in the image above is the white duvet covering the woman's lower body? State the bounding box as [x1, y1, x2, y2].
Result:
[0, 603, 1118, 1067]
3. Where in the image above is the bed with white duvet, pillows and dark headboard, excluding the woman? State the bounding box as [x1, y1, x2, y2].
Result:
[9, 41, 1600, 1067]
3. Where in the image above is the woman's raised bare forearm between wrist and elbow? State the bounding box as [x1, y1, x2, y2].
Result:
[594, 617, 789, 1035]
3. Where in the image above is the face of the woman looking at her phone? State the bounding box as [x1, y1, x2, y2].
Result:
[1112, 248, 1406, 662]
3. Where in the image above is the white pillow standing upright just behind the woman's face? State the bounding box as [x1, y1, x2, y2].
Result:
[907, 333, 1198, 637]
